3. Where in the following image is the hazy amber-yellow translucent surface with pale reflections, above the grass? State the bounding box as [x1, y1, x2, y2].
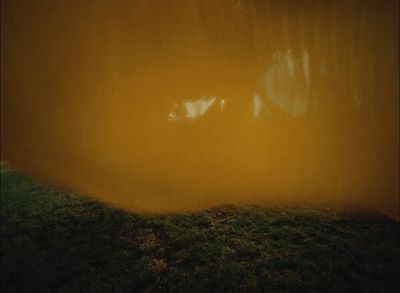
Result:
[1, 0, 399, 217]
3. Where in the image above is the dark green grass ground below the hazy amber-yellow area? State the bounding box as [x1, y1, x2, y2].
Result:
[1, 168, 400, 292]
